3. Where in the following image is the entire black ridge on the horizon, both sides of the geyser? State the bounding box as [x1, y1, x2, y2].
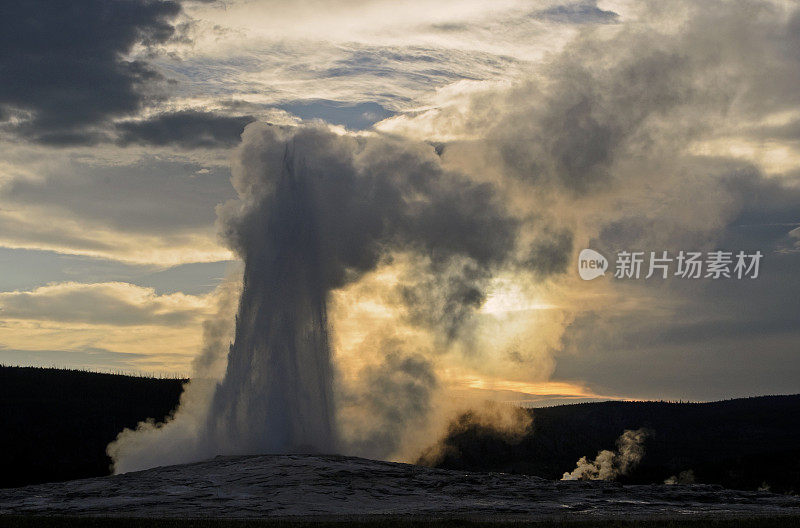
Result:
[0, 366, 800, 492]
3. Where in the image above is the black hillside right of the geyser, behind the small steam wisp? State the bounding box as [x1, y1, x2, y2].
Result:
[418, 395, 800, 493]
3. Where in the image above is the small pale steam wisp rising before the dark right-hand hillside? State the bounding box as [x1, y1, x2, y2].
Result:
[561, 429, 652, 480]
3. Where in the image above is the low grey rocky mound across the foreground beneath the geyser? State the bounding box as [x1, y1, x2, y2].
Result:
[0, 455, 800, 519]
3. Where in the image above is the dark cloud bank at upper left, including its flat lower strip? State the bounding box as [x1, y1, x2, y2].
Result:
[0, 0, 252, 148]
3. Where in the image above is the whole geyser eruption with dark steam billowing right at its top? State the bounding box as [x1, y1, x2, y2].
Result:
[109, 123, 517, 471]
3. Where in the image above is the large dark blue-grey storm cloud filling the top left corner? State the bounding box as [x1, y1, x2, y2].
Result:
[0, 0, 180, 145]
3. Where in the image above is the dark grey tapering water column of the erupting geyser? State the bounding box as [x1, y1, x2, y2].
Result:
[207, 143, 336, 453]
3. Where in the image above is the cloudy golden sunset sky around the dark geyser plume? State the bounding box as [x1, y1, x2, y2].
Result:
[0, 0, 800, 404]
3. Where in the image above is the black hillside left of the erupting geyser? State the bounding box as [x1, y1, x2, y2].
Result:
[0, 366, 183, 487]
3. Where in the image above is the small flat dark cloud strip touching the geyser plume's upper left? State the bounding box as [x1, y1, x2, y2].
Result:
[116, 110, 255, 149]
